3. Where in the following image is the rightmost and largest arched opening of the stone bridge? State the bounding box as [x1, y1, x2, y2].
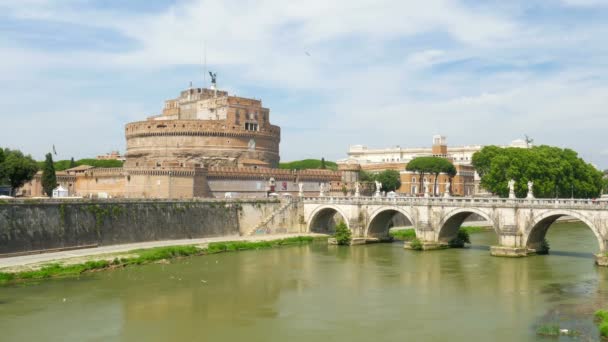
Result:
[525, 212, 604, 254]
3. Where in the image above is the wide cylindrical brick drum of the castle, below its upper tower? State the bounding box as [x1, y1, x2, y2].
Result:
[125, 120, 281, 168]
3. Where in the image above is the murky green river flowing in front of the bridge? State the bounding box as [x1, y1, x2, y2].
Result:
[0, 223, 608, 342]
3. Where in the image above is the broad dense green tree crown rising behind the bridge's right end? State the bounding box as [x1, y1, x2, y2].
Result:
[473, 145, 603, 198]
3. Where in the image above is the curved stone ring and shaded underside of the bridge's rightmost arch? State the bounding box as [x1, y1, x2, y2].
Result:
[523, 209, 606, 251]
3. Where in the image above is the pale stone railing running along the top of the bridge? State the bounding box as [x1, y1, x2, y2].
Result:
[303, 196, 608, 209]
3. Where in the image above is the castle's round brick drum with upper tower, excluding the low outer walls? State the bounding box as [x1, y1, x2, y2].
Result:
[125, 87, 281, 168]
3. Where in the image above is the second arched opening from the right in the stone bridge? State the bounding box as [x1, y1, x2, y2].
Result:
[437, 210, 498, 246]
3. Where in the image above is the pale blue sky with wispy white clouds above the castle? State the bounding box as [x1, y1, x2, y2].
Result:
[0, 0, 608, 168]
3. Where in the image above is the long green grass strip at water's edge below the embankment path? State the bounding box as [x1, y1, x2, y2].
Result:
[0, 236, 316, 285]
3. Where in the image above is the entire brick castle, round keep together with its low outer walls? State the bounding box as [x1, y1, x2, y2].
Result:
[23, 75, 343, 198]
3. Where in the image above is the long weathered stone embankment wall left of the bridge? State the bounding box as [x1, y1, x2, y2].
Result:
[0, 200, 301, 254]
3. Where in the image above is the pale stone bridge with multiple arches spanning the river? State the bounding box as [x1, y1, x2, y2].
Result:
[302, 197, 608, 256]
